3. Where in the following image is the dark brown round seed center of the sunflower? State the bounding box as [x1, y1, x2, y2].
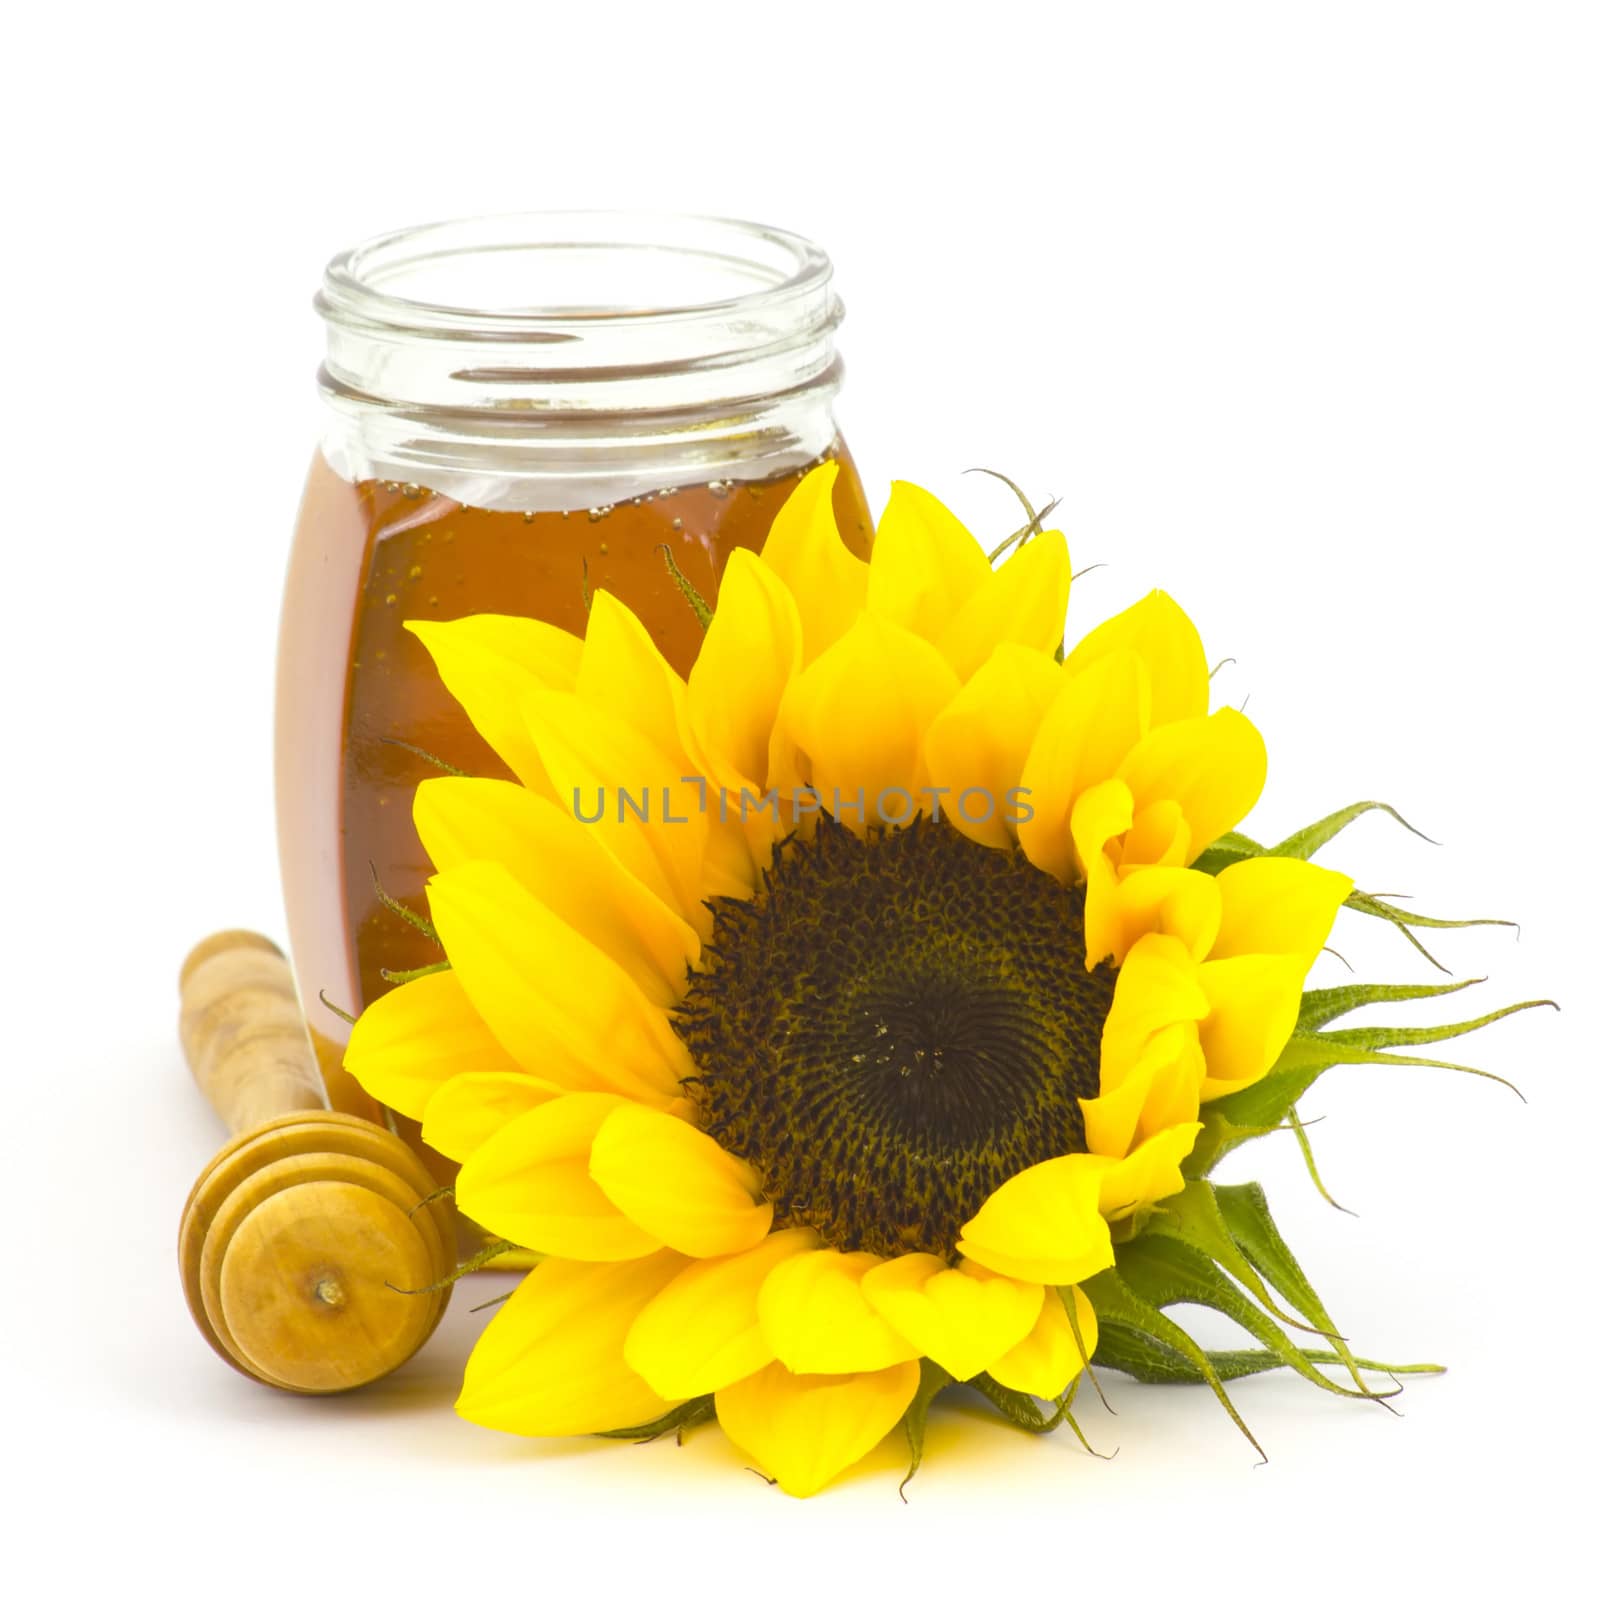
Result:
[675, 818, 1115, 1254]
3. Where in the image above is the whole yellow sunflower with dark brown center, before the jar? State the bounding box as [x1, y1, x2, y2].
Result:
[347, 466, 1542, 1494]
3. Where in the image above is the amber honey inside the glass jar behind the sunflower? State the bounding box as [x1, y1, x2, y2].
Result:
[277, 445, 872, 1152]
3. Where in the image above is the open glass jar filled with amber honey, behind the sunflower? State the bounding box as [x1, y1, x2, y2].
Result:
[277, 213, 872, 1164]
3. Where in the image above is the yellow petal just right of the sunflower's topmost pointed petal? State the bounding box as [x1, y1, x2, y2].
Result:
[867, 482, 995, 642]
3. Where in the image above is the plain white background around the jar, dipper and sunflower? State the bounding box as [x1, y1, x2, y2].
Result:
[0, 0, 1600, 1595]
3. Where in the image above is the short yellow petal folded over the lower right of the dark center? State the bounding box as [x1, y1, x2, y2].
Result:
[957, 1155, 1112, 1283]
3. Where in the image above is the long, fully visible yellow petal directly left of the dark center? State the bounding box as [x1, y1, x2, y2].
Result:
[427, 861, 690, 1102]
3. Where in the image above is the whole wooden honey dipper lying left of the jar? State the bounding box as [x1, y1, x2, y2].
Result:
[178, 931, 456, 1394]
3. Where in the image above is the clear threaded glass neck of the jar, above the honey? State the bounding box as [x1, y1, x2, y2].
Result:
[317, 211, 843, 491]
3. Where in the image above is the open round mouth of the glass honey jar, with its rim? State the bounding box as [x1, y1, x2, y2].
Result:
[317, 211, 842, 340]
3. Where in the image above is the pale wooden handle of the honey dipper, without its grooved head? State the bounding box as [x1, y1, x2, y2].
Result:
[178, 930, 328, 1134]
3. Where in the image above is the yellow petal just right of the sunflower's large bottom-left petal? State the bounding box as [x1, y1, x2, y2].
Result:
[622, 1227, 819, 1400]
